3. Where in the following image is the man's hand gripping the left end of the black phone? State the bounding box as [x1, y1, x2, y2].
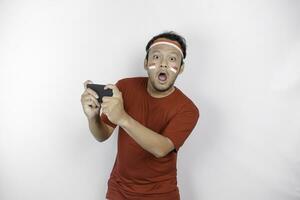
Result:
[81, 80, 101, 119]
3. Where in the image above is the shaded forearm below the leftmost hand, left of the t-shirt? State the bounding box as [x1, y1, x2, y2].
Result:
[88, 116, 108, 142]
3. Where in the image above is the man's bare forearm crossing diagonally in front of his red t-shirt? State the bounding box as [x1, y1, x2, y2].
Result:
[119, 113, 174, 158]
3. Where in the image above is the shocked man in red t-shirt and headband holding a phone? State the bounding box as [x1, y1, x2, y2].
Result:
[81, 31, 199, 200]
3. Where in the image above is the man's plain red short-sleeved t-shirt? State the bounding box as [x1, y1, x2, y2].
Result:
[101, 77, 199, 200]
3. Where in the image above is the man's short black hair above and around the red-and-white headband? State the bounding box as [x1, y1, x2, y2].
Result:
[146, 31, 186, 67]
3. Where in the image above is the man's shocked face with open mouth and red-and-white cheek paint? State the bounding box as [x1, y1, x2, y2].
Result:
[145, 39, 183, 92]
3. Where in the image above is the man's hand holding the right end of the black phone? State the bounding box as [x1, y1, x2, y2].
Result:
[101, 84, 127, 125]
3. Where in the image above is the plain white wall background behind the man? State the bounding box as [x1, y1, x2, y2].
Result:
[0, 0, 300, 200]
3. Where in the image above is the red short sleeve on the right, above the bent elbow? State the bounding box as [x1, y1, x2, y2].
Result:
[162, 106, 200, 152]
